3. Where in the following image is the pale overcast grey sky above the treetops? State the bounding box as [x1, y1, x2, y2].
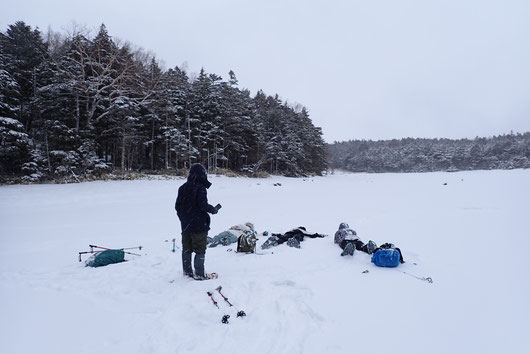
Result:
[0, 0, 530, 142]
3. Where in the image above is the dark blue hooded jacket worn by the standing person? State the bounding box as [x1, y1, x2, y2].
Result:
[175, 163, 217, 234]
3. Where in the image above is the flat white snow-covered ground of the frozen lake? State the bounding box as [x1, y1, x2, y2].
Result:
[0, 170, 530, 354]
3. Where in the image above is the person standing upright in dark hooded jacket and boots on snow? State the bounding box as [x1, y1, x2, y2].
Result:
[175, 163, 221, 280]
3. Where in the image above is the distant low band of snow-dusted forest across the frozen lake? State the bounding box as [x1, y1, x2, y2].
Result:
[328, 132, 530, 172]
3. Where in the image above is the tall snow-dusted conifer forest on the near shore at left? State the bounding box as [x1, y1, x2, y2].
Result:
[0, 22, 327, 182]
